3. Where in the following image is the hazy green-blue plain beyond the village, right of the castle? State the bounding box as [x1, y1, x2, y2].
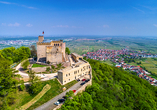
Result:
[66, 36, 157, 55]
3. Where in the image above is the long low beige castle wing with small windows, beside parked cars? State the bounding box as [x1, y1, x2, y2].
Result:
[58, 53, 92, 85]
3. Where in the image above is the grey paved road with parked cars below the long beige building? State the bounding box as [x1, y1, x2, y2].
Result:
[34, 81, 82, 110]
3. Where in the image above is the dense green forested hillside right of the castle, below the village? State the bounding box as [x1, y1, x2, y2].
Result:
[61, 59, 157, 110]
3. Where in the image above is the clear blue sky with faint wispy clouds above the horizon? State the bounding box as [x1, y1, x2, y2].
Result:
[0, 0, 157, 36]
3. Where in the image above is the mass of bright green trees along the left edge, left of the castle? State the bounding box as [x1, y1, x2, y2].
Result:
[0, 47, 31, 110]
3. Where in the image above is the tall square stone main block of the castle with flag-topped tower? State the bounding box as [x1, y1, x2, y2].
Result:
[37, 36, 66, 64]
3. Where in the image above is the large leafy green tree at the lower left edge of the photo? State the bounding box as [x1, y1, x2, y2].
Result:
[0, 58, 17, 109]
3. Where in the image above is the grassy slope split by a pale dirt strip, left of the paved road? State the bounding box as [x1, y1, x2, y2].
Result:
[10, 79, 77, 110]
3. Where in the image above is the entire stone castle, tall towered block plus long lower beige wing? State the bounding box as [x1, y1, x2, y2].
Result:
[37, 36, 92, 85]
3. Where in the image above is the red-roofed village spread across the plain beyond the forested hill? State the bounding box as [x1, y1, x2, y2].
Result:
[83, 48, 157, 86]
